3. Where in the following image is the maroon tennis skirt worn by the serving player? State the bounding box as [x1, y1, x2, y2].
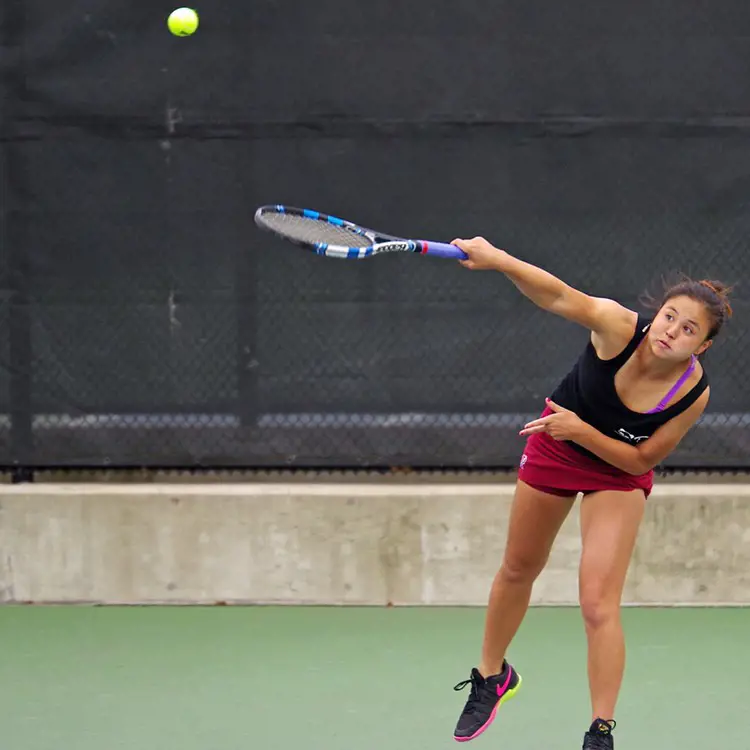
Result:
[518, 408, 654, 497]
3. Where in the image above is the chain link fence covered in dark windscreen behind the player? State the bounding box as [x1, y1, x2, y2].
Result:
[0, 0, 750, 469]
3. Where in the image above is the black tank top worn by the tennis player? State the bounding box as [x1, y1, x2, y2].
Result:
[550, 315, 708, 461]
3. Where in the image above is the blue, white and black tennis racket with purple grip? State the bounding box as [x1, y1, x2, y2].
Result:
[255, 206, 468, 260]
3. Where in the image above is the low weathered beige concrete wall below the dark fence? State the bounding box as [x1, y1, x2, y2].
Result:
[0, 483, 750, 605]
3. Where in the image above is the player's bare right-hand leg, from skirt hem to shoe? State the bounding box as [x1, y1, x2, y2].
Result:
[579, 490, 646, 720]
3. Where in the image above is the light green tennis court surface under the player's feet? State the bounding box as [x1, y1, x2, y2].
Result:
[0, 607, 750, 750]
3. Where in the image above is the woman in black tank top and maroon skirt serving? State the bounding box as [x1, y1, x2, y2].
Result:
[453, 237, 732, 750]
